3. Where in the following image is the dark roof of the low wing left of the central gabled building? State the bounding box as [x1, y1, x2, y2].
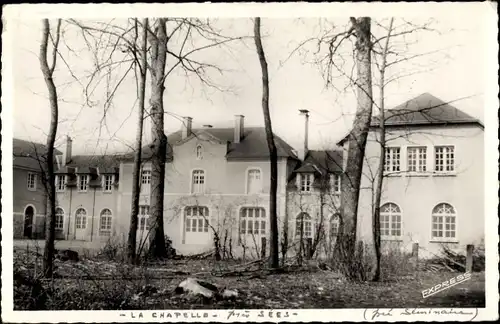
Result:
[57, 155, 120, 173]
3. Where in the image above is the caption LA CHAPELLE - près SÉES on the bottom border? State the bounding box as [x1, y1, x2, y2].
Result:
[120, 310, 298, 320]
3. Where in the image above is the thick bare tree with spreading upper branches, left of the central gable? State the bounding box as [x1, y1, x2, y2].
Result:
[70, 18, 244, 257]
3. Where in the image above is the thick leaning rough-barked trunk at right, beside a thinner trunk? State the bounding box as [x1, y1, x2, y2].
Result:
[338, 17, 373, 280]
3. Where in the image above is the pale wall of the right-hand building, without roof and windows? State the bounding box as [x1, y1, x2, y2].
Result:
[358, 126, 485, 256]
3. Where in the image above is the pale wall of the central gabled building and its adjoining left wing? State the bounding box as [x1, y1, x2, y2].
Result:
[70, 133, 290, 255]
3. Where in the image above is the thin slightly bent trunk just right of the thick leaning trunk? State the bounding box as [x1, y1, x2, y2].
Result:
[372, 18, 394, 281]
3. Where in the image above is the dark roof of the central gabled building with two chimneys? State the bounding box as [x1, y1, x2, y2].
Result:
[121, 127, 297, 160]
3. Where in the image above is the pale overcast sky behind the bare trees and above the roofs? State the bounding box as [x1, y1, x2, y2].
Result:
[5, 6, 494, 154]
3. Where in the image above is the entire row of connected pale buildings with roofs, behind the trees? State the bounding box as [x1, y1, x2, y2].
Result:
[14, 94, 484, 257]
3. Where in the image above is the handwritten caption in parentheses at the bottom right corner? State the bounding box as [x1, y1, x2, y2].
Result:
[363, 308, 478, 321]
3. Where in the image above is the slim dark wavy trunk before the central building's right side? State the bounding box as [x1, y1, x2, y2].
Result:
[254, 17, 279, 268]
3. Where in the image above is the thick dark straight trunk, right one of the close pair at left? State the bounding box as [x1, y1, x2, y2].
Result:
[149, 18, 168, 258]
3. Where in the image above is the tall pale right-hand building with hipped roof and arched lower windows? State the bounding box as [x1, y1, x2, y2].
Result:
[358, 93, 485, 256]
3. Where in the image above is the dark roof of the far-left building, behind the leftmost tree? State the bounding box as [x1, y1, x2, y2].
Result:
[12, 138, 62, 170]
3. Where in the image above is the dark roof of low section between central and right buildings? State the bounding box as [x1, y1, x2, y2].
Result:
[294, 150, 343, 174]
